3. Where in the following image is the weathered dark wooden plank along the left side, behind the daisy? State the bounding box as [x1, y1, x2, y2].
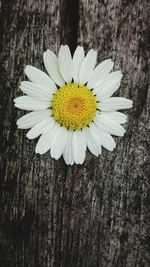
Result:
[1, 0, 68, 266]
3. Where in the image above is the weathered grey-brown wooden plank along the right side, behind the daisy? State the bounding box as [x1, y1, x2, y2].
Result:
[78, 0, 150, 267]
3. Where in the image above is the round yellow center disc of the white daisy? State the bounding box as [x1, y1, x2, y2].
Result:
[51, 83, 97, 130]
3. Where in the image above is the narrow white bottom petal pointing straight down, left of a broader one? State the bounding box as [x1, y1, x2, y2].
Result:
[63, 130, 74, 165]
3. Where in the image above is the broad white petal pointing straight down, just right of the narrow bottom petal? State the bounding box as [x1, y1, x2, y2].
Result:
[72, 131, 86, 164]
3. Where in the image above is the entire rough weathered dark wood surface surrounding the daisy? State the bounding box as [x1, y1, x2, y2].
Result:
[0, 0, 150, 267]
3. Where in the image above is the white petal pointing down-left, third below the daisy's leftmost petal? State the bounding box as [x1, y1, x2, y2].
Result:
[35, 123, 60, 154]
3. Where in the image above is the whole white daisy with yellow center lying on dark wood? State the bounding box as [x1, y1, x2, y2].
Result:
[14, 45, 132, 165]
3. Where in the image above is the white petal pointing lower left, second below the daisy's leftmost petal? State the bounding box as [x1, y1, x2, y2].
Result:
[26, 117, 54, 139]
